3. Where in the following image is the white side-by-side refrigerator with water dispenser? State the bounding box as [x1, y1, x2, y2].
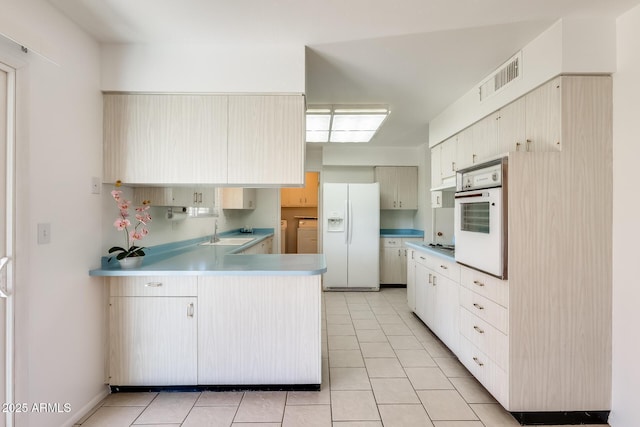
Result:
[322, 183, 380, 290]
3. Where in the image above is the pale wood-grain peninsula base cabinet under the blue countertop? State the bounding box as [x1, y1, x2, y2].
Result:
[108, 275, 322, 389]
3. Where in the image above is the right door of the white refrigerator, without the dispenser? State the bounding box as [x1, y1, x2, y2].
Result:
[347, 183, 380, 288]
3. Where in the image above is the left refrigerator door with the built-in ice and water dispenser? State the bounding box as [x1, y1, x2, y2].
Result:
[322, 183, 349, 288]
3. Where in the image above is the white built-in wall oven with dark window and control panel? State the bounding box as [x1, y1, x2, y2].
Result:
[454, 157, 508, 279]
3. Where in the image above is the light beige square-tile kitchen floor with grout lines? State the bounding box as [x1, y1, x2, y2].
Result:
[77, 288, 604, 427]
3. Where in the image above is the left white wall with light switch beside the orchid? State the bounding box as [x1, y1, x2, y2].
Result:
[0, 0, 107, 427]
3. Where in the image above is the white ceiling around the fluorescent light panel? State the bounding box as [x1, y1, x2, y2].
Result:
[49, 0, 640, 147]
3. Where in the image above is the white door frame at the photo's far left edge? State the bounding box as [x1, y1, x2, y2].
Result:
[0, 62, 16, 427]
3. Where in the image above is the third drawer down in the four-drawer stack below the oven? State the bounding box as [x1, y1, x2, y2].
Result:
[460, 307, 509, 371]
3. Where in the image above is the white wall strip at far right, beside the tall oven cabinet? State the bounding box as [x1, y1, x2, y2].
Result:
[609, 6, 640, 427]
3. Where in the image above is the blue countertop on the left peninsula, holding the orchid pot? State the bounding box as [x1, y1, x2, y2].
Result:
[89, 229, 327, 276]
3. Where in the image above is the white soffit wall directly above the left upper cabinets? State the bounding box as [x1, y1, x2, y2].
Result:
[102, 41, 305, 93]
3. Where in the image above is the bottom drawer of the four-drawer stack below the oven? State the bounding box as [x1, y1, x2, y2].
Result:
[458, 337, 509, 409]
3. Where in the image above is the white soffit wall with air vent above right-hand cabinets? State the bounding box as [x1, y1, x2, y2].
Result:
[429, 18, 616, 147]
